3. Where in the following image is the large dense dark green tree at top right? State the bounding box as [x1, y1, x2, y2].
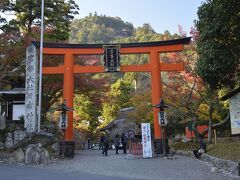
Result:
[196, 0, 240, 89]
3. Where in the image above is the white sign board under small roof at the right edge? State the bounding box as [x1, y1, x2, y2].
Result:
[229, 93, 240, 134]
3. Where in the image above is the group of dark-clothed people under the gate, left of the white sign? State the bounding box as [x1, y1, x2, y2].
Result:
[99, 131, 128, 156]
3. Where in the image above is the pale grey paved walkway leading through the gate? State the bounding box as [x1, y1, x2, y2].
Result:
[45, 150, 237, 180]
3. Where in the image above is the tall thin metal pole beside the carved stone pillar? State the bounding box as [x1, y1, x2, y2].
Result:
[38, 0, 44, 132]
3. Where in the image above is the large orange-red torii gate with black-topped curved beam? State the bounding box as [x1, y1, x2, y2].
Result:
[38, 37, 191, 149]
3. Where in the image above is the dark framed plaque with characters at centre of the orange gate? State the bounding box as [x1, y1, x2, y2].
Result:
[103, 45, 120, 72]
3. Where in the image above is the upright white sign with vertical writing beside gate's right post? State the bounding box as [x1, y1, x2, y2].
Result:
[141, 123, 152, 158]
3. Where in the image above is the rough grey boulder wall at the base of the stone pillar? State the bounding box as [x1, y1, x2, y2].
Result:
[0, 130, 59, 165]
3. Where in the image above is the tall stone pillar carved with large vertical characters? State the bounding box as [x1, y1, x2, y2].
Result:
[24, 45, 38, 132]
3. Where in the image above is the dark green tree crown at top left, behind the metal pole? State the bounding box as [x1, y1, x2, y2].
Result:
[0, 0, 78, 41]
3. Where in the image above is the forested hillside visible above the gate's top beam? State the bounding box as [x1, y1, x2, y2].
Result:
[70, 13, 179, 44]
